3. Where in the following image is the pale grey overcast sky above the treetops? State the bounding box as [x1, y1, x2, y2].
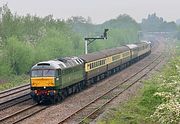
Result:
[0, 0, 180, 24]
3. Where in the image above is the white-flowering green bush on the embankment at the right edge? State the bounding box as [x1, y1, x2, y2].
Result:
[151, 57, 180, 124]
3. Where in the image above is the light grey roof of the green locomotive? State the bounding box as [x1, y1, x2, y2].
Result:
[32, 57, 84, 69]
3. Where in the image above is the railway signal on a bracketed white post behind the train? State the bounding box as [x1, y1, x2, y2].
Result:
[84, 29, 109, 54]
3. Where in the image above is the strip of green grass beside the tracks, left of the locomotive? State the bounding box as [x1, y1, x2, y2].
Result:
[0, 75, 29, 91]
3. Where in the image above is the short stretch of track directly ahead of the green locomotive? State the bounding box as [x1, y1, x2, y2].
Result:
[0, 103, 49, 124]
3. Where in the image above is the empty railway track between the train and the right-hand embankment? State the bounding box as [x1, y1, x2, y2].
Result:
[59, 51, 164, 124]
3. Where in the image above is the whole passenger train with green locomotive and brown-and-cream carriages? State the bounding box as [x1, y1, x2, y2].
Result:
[30, 41, 151, 103]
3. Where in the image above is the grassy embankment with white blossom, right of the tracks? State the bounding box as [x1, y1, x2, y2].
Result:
[99, 42, 180, 124]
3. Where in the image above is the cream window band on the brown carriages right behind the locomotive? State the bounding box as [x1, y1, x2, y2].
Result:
[85, 51, 130, 72]
